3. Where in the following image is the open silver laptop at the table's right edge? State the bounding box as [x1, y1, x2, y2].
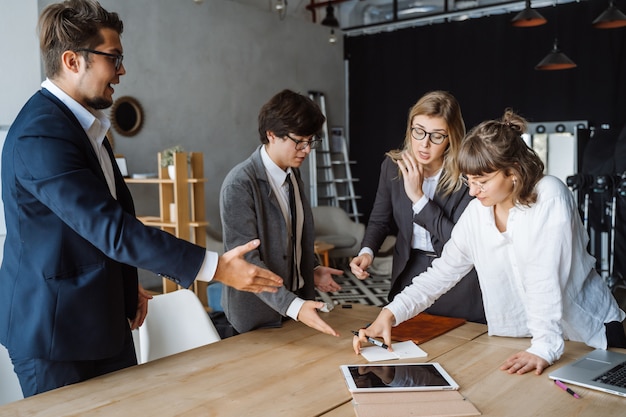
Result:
[548, 349, 626, 397]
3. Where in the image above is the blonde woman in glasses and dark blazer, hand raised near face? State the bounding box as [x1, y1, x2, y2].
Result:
[350, 91, 485, 323]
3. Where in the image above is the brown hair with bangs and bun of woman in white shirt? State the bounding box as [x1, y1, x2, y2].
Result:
[458, 109, 544, 206]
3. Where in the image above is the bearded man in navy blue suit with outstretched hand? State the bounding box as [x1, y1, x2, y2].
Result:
[0, 0, 282, 396]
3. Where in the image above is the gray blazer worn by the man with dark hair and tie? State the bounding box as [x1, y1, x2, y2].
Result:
[220, 147, 317, 333]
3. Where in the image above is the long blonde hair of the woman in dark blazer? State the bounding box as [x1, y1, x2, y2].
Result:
[386, 91, 465, 194]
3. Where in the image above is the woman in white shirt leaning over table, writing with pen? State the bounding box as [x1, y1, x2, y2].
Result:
[353, 109, 626, 374]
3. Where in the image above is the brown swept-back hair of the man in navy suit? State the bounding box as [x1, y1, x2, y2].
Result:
[38, 0, 124, 78]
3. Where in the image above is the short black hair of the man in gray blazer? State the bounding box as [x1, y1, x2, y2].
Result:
[259, 90, 326, 144]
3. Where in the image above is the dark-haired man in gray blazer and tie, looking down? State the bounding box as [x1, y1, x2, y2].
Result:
[220, 90, 343, 336]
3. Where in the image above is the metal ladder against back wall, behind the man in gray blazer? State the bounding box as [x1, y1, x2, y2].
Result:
[309, 91, 361, 223]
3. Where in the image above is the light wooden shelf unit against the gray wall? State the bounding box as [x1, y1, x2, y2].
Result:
[126, 152, 209, 307]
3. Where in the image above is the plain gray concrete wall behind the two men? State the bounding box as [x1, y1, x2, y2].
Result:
[31, 0, 345, 230]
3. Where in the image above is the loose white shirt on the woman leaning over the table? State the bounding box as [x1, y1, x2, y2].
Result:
[386, 176, 625, 364]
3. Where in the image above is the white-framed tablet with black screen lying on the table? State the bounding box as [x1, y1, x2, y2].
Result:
[341, 363, 459, 392]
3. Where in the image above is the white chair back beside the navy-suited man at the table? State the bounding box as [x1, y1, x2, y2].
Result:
[137, 289, 220, 364]
